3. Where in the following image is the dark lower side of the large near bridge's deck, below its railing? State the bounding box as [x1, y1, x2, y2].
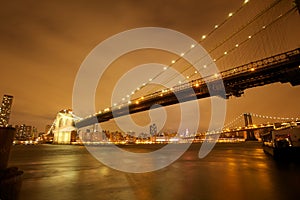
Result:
[76, 49, 300, 128]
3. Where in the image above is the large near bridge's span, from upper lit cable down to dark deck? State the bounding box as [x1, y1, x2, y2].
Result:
[49, 0, 300, 136]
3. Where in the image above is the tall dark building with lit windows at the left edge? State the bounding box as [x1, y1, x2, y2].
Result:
[0, 95, 13, 127]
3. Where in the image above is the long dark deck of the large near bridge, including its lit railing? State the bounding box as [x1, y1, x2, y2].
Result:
[76, 48, 300, 128]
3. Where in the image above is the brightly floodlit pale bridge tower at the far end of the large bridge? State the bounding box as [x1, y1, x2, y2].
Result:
[53, 109, 77, 144]
